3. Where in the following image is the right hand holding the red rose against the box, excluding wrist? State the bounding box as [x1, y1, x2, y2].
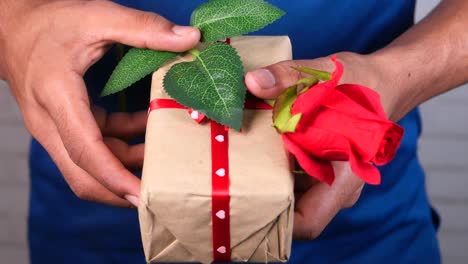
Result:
[245, 53, 391, 239]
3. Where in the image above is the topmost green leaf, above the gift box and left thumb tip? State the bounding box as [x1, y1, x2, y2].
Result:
[191, 0, 284, 42]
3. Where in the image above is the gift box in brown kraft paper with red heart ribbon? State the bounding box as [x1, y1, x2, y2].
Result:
[138, 36, 294, 263]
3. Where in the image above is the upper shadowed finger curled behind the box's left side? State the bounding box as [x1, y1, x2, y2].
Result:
[91, 106, 148, 140]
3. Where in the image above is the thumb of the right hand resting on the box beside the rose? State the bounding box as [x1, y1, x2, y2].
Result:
[245, 58, 333, 99]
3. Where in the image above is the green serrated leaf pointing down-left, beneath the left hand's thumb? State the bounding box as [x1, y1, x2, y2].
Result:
[101, 48, 178, 96]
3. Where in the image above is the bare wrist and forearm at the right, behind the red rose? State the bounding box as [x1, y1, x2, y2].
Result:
[369, 1, 468, 121]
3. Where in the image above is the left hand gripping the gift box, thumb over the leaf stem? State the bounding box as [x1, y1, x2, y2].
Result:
[0, 0, 200, 207]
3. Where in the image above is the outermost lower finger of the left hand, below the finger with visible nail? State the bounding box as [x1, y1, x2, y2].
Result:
[25, 104, 133, 207]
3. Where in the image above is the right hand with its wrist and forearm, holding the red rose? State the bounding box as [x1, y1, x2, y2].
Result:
[246, 0, 468, 239]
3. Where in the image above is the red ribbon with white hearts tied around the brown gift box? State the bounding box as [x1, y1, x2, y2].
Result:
[149, 99, 272, 262]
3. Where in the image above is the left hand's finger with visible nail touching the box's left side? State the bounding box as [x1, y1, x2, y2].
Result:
[36, 74, 140, 202]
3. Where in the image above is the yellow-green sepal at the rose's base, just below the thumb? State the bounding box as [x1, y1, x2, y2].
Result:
[273, 85, 302, 134]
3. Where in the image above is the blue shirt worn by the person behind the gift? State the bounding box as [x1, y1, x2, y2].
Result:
[29, 0, 440, 264]
